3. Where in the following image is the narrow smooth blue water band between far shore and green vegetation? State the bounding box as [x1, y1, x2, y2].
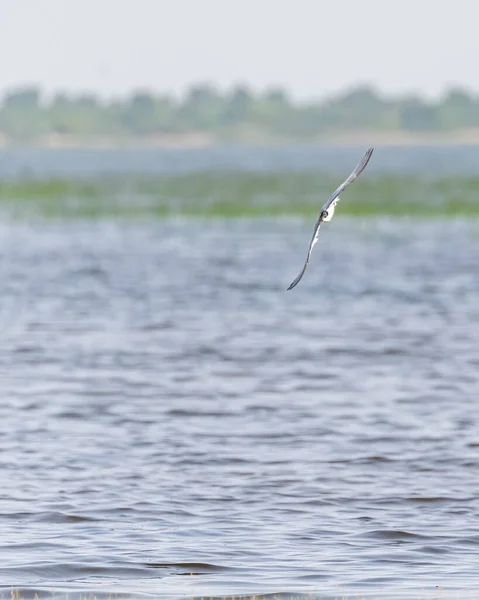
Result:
[0, 145, 479, 179]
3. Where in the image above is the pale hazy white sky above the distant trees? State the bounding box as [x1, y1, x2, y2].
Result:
[0, 0, 479, 98]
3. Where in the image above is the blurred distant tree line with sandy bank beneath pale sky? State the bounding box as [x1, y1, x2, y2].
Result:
[0, 84, 479, 143]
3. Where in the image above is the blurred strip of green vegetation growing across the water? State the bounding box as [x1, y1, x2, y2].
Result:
[0, 172, 479, 218]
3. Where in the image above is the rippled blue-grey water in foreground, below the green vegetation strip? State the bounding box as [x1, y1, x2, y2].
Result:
[0, 217, 479, 598]
